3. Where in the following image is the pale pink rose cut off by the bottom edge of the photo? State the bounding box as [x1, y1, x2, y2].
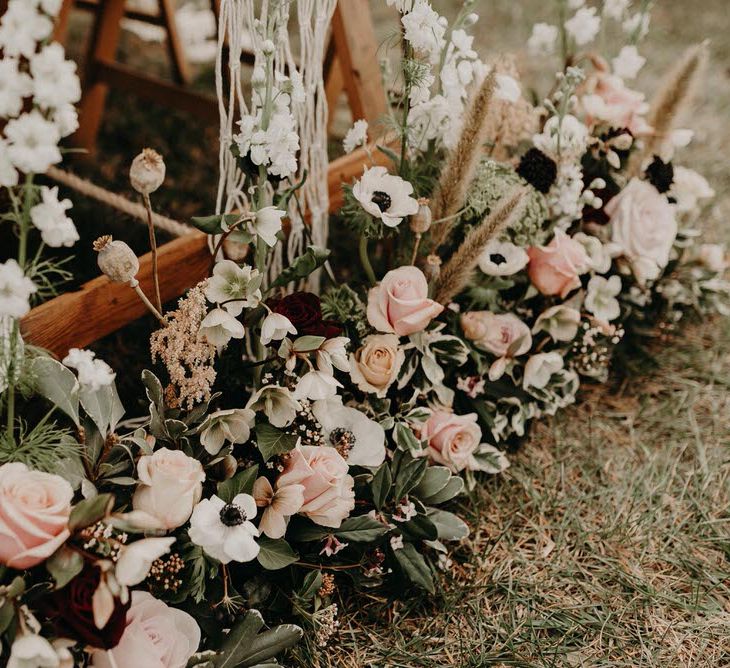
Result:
[91, 591, 200, 668]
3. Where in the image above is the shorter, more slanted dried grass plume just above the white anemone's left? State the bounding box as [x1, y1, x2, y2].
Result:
[434, 188, 526, 305]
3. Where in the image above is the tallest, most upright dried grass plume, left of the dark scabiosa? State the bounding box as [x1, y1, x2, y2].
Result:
[431, 67, 497, 249]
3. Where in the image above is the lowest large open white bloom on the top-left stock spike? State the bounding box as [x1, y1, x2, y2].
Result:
[5, 109, 61, 174]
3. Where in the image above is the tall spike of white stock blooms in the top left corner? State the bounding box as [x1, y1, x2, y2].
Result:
[0, 0, 81, 188]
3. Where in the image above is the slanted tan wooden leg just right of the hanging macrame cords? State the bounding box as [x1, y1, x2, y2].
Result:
[332, 0, 388, 124]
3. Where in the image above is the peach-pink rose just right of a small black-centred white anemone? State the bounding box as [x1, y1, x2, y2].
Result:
[527, 230, 590, 298]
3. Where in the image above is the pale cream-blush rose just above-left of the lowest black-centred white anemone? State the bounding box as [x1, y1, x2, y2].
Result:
[132, 448, 205, 529]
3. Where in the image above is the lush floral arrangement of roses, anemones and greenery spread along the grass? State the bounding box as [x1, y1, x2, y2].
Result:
[0, 0, 730, 668]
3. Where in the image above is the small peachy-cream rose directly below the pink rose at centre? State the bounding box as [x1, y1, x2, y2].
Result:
[350, 334, 405, 397]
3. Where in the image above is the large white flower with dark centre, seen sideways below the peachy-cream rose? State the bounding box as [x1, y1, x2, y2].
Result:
[312, 397, 385, 466]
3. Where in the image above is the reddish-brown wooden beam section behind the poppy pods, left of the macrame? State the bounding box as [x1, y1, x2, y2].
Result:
[20, 232, 210, 357]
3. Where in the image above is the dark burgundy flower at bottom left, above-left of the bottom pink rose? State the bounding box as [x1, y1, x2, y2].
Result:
[40, 564, 129, 649]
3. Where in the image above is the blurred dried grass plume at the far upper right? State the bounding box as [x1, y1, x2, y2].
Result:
[631, 40, 709, 174]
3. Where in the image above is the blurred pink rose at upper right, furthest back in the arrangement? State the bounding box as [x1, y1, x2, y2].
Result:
[581, 73, 651, 137]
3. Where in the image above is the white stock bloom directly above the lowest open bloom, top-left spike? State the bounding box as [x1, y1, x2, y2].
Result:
[30, 42, 81, 109]
